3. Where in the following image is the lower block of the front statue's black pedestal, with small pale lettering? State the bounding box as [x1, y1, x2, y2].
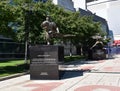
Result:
[30, 64, 59, 80]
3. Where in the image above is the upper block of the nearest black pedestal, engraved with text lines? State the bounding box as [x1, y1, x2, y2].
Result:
[30, 45, 64, 64]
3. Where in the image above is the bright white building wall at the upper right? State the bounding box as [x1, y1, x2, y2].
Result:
[87, 0, 120, 40]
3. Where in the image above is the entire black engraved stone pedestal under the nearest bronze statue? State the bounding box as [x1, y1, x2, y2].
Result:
[30, 45, 64, 80]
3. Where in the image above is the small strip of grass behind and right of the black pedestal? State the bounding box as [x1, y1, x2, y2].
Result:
[64, 55, 85, 62]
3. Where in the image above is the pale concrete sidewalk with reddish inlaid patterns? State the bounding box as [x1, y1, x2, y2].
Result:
[0, 55, 120, 91]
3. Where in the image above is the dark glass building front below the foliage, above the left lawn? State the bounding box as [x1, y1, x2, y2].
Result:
[0, 41, 25, 60]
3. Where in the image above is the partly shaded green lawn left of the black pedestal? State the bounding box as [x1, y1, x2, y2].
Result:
[0, 60, 29, 77]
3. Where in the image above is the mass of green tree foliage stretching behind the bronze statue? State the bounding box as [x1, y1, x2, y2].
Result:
[0, 0, 107, 47]
